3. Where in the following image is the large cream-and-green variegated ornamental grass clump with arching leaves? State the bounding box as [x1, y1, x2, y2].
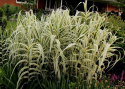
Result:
[7, 1, 120, 88]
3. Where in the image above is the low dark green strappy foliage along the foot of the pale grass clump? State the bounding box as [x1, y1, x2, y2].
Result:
[21, 76, 118, 89]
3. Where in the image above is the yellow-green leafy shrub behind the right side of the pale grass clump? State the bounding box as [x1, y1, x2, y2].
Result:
[106, 15, 125, 62]
